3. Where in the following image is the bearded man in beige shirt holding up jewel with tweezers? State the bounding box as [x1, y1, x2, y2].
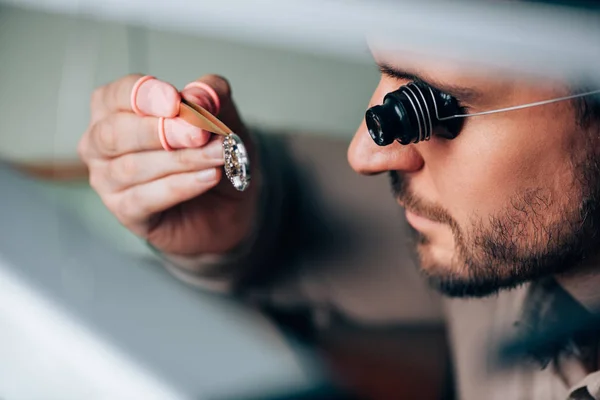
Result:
[79, 42, 600, 399]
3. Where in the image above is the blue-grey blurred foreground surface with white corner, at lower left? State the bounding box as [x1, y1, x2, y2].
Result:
[0, 166, 328, 399]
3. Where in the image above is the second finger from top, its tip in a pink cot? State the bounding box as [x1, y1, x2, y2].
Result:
[81, 112, 210, 158]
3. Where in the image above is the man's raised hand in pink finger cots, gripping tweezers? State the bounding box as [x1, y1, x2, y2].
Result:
[78, 75, 260, 256]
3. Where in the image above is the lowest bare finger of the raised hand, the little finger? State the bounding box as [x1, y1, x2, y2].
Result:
[109, 168, 221, 224]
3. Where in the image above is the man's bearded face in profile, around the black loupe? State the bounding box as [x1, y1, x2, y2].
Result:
[348, 53, 600, 296]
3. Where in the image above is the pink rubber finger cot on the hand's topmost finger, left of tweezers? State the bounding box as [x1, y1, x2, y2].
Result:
[136, 79, 179, 117]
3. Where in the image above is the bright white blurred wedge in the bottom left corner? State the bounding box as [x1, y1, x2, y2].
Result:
[0, 253, 184, 400]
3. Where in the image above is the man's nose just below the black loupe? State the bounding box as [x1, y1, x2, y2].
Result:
[348, 119, 424, 175]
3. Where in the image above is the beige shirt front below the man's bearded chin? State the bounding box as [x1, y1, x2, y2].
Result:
[445, 286, 600, 400]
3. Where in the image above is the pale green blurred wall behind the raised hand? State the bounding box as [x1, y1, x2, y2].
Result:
[0, 6, 378, 161]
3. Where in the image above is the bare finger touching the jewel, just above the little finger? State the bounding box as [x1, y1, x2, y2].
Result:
[100, 137, 224, 192]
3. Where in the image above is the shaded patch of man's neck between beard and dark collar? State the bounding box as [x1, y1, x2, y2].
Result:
[556, 255, 600, 313]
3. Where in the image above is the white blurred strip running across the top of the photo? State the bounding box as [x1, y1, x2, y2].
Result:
[0, 0, 600, 80]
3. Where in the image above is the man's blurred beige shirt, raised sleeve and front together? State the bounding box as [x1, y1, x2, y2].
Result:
[154, 132, 600, 400]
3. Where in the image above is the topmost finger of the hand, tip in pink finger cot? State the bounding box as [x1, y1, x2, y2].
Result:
[92, 74, 181, 119]
